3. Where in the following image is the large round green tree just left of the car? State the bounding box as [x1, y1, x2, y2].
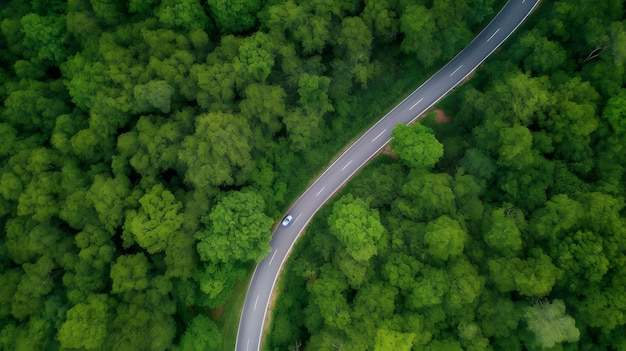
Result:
[196, 191, 274, 263]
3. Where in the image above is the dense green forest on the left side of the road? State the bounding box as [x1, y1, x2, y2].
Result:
[0, 0, 494, 350]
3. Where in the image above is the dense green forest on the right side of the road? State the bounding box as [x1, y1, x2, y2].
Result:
[266, 0, 626, 351]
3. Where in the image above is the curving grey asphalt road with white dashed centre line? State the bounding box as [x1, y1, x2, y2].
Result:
[236, 0, 540, 351]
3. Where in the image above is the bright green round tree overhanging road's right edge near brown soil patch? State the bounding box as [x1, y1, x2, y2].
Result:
[391, 123, 443, 170]
